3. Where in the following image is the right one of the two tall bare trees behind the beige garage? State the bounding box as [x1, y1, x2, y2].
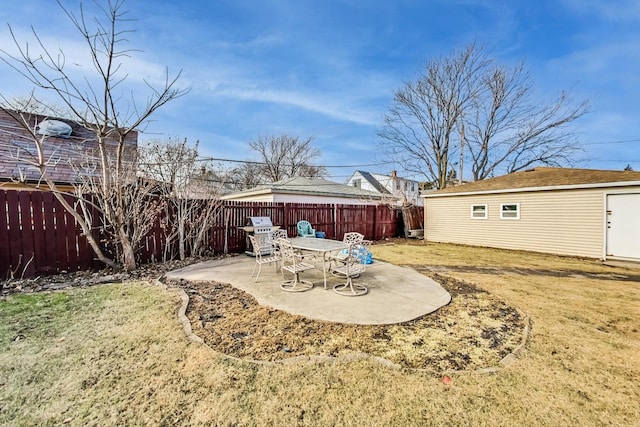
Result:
[464, 64, 588, 180]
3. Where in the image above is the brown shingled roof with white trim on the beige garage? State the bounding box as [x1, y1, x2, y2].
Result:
[425, 167, 640, 197]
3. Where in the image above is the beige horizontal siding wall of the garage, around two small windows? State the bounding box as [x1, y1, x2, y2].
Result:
[425, 188, 604, 258]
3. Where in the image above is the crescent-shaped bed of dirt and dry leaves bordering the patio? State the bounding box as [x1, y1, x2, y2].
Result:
[165, 274, 526, 372]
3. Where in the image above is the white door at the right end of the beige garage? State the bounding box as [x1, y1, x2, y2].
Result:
[607, 194, 640, 260]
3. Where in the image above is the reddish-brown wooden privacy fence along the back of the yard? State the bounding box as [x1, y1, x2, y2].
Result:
[0, 190, 410, 280]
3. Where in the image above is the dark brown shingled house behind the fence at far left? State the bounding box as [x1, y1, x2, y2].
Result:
[0, 109, 138, 189]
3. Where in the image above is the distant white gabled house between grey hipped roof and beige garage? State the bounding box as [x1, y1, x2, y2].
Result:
[347, 170, 423, 206]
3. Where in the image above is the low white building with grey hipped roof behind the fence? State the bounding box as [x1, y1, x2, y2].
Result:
[221, 177, 395, 205]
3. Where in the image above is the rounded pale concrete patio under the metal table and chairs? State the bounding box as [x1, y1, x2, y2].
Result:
[167, 255, 451, 325]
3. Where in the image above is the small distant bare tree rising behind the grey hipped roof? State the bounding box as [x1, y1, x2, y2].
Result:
[244, 135, 327, 184]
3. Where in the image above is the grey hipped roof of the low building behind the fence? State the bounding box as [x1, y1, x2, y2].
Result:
[222, 177, 390, 200]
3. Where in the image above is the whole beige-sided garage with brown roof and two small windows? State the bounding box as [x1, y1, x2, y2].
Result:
[424, 167, 640, 261]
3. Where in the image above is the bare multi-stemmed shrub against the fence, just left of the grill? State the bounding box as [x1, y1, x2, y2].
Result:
[140, 139, 224, 260]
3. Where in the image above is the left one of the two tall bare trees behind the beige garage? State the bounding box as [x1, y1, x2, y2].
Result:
[378, 45, 487, 188]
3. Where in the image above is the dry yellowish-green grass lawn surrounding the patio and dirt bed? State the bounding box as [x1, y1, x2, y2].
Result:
[0, 241, 640, 426]
